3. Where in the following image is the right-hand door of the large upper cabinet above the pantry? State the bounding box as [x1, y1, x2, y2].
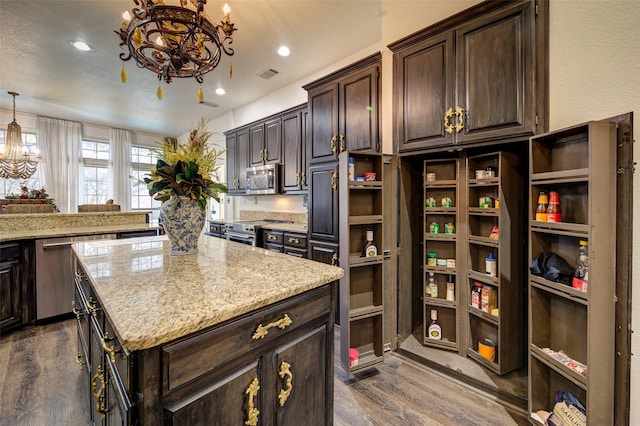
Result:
[456, 2, 536, 143]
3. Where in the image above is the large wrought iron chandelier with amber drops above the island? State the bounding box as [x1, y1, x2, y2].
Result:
[116, 0, 236, 102]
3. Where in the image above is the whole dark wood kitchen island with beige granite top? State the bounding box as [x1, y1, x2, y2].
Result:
[73, 237, 343, 425]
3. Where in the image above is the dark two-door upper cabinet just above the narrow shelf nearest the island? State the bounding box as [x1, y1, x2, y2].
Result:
[304, 52, 381, 164]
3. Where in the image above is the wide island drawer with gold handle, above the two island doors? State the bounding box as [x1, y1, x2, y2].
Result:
[161, 285, 332, 394]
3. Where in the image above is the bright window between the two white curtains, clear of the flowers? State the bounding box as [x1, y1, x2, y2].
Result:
[80, 140, 110, 204]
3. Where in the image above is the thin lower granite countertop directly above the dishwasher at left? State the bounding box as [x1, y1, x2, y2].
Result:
[0, 223, 161, 242]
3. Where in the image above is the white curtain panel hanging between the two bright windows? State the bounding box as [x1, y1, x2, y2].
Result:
[111, 129, 131, 211]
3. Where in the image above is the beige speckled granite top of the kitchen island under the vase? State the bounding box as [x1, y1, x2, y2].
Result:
[72, 236, 344, 351]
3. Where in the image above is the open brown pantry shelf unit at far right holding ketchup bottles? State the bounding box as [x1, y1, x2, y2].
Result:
[528, 122, 617, 425]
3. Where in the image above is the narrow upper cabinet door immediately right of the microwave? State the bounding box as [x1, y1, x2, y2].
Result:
[281, 111, 303, 193]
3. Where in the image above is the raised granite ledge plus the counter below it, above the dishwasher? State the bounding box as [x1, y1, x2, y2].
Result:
[0, 211, 160, 242]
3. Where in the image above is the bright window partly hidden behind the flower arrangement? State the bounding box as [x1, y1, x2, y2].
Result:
[131, 146, 161, 222]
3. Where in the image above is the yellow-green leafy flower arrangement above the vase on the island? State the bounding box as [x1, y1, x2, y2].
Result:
[144, 118, 227, 210]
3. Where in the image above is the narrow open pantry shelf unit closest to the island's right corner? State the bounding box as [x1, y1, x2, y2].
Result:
[338, 151, 390, 373]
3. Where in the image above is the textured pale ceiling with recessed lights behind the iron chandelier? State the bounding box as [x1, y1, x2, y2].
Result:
[0, 0, 381, 136]
